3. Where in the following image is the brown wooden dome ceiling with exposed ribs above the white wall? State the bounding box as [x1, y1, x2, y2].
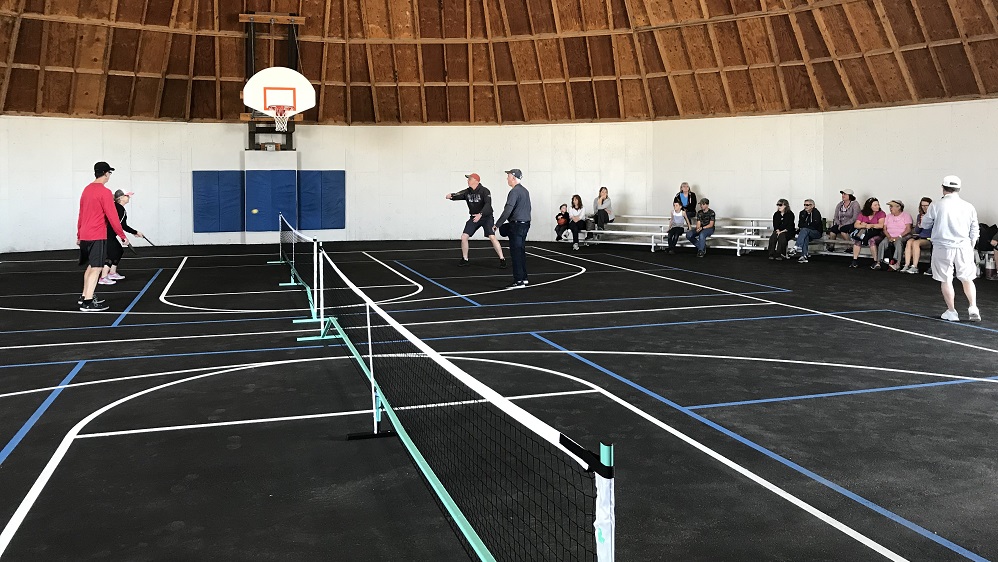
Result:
[0, 0, 998, 124]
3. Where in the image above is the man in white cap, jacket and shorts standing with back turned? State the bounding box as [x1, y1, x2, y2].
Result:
[922, 176, 981, 322]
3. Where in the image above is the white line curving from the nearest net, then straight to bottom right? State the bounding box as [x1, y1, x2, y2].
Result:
[449, 351, 906, 562]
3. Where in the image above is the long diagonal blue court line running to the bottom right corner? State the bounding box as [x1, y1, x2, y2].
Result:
[532, 333, 988, 562]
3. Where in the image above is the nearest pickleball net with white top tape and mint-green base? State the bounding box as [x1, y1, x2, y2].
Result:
[308, 245, 614, 562]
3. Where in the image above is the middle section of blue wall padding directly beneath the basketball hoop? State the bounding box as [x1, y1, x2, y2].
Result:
[245, 170, 298, 232]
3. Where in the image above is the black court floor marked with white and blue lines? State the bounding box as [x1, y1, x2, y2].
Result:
[0, 241, 998, 561]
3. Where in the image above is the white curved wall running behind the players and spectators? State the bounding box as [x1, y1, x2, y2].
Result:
[0, 96, 998, 252]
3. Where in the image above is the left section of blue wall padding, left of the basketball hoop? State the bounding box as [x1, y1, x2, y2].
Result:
[192, 170, 243, 232]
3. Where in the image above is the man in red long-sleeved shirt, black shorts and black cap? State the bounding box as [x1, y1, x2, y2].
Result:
[76, 162, 128, 312]
